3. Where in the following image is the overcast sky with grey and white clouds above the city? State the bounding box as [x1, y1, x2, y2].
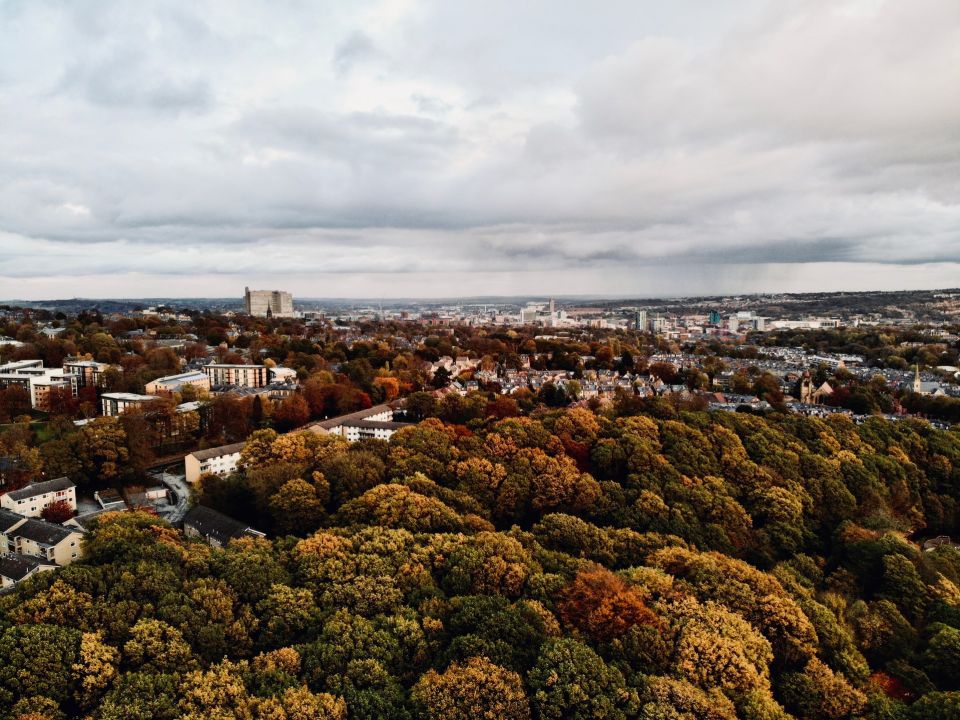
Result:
[0, 0, 960, 299]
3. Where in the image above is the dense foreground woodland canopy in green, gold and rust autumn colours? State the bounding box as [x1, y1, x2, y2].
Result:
[0, 408, 960, 720]
